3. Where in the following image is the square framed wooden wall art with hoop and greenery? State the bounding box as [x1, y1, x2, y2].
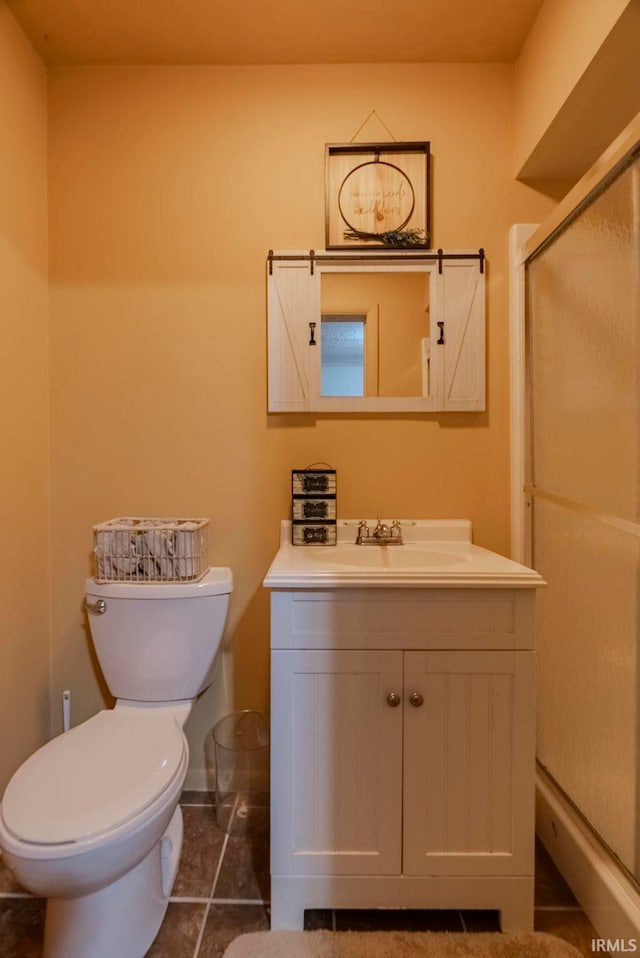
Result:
[325, 142, 433, 250]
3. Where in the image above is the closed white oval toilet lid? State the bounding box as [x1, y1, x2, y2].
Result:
[2, 708, 186, 845]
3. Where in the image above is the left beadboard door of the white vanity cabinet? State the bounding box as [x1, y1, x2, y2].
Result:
[271, 651, 402, 875]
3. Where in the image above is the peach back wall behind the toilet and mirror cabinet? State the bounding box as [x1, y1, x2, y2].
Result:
[50, 65, 553, 784]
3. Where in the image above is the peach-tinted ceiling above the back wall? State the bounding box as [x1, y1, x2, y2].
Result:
[5, 0, 543, 66]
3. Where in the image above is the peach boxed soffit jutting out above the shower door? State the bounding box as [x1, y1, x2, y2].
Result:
[514, 0, 640, 183]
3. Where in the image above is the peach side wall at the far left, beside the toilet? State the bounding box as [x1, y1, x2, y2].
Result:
[0, 2, 49, 793]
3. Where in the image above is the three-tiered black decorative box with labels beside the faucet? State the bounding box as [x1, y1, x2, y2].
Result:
[291, 469, 337, 546]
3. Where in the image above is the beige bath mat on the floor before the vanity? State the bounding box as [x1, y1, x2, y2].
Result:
[224, 931, 581, 958]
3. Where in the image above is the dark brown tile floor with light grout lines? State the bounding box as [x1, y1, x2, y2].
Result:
[0, 792, 597, 958]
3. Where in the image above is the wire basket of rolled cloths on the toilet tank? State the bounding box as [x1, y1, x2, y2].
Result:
[93, 516, 209, 583]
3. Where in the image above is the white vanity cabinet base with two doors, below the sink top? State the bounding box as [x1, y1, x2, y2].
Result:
[271, 588, 535, 930]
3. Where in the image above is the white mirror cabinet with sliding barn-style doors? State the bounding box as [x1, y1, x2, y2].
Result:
[267, 250, 485, 412]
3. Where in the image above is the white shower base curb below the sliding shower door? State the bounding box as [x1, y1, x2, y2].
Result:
[536, 769, 640, 942]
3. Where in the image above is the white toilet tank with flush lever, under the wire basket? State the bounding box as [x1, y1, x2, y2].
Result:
[85, 568, 233, 702]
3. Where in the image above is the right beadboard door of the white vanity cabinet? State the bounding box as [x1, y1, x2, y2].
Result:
[403, 652, 535, 876]
